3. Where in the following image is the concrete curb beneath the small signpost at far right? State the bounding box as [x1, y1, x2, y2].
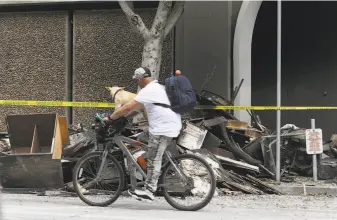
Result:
[278, 184, 337, 196]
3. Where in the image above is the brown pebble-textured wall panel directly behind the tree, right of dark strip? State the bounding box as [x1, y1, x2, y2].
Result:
[73, 10, 173, 125]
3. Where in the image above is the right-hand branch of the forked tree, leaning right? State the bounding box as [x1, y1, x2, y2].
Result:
[151, 0, 172, 37]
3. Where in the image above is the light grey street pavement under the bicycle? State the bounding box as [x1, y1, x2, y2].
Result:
[0, 194, 337, 220]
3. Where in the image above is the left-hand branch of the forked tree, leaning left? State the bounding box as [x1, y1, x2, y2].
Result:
[118, 0, 150, 40]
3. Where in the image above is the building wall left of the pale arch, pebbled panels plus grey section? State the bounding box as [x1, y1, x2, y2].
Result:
[0, 1, 242, 130]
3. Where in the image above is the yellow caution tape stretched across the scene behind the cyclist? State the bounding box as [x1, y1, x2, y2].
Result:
[0, 100, 337, 111]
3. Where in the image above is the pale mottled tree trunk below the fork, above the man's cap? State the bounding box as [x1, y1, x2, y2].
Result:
[142, 36, 164, 79]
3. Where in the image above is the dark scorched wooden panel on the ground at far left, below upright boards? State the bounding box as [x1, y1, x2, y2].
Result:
[0, 154, 63, 189]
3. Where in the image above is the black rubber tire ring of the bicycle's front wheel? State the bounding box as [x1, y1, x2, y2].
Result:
[72, 151, 125, 207]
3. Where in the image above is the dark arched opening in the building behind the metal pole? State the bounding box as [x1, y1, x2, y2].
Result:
[252, 2, 337, 139]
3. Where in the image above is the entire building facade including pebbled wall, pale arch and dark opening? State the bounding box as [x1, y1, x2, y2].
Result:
[0, 1, 337, 139]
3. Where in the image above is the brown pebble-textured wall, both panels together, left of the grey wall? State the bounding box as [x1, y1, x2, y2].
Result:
[0, 9, 173, 131]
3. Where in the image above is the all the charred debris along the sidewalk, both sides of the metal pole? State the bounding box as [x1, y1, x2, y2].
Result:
[0, 80, 337, 194]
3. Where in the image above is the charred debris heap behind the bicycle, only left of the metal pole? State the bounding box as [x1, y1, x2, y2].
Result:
[63, 87, 281, 194]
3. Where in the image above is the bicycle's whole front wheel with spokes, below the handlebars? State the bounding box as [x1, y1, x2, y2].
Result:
[73, 152, 125, 206]
